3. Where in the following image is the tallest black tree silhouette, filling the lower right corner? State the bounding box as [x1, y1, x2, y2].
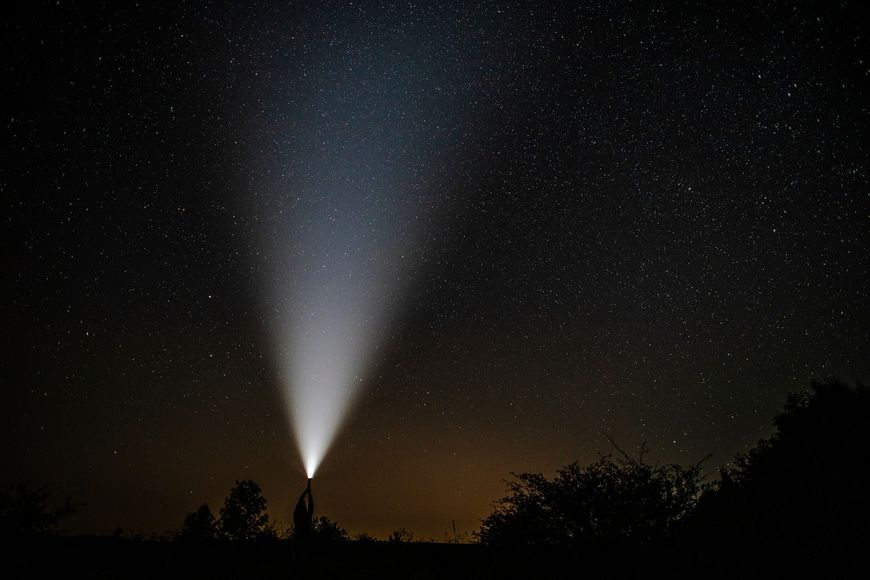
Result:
[690, 379, 870, 572]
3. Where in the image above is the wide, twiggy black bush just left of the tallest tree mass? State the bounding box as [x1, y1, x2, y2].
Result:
[476, 445, 700, 546]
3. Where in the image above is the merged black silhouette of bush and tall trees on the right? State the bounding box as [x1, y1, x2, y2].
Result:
[477, 379, 870, 578]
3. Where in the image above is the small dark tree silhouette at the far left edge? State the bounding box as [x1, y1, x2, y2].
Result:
[0, 483, 75, 539]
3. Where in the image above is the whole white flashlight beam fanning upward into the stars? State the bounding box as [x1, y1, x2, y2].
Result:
[253, 7, 487, 477]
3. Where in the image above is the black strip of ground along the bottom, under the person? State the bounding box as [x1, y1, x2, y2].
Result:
[8, 536, 862, 579]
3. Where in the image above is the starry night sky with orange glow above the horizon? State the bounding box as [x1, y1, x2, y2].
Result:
[0, 1, 870, 540]
